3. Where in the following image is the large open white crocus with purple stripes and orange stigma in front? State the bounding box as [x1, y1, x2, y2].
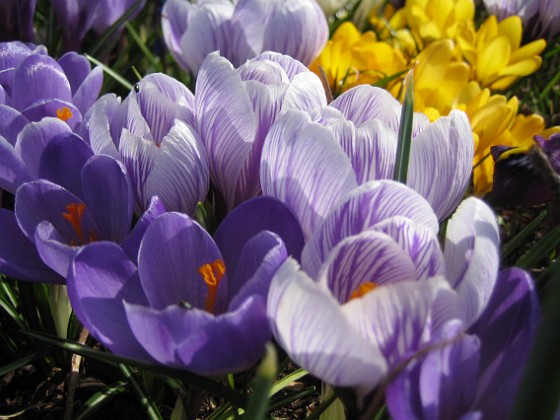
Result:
[267, 181, 499, 398]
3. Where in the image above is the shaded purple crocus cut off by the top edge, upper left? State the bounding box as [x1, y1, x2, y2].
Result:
[51, 0, 144, 50]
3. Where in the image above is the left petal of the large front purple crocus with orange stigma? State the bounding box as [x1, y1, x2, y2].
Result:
[67, 242, 152, 361]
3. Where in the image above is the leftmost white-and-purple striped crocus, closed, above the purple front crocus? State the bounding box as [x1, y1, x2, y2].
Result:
[84, 73, 209, 214]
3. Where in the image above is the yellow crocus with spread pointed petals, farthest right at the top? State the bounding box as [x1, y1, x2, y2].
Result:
[457, 16, 546, 90]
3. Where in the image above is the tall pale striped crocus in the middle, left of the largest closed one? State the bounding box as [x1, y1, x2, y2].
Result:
[195, 52, 326, 210]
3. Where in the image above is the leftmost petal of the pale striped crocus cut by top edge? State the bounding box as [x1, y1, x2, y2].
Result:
[161, 0, 197, 71]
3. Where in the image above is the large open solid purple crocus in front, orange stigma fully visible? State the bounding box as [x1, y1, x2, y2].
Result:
[68, 197, 303, 375]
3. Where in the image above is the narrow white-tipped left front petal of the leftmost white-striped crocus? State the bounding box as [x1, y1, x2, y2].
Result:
[119, 129, 159, 212]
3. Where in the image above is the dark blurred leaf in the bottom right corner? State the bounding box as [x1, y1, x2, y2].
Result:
[511, 259, 560, 420]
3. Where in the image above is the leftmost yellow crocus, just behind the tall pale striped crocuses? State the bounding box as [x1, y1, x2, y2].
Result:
[309, 22, 407, 96]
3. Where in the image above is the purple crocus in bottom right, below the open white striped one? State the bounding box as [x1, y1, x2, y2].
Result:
[386, 269, 539, 420]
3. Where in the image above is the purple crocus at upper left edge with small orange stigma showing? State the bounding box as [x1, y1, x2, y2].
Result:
[0, 42, 103, 145]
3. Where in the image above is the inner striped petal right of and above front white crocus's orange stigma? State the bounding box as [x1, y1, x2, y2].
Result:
[373, 216, 445, 280]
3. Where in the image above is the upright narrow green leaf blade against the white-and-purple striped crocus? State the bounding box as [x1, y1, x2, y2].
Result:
[393, 70, 414, 184]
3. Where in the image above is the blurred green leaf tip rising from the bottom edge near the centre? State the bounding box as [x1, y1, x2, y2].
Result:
[244, 343, 278, 420]
